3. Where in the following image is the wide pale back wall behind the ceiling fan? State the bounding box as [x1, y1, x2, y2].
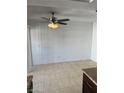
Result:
[31, 22, 93, 65]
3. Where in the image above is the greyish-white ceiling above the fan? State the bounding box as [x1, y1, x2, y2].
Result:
[27, 0, 97, 23]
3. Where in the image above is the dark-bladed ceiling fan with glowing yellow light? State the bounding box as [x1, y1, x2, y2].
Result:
[41, 12, 70, 29]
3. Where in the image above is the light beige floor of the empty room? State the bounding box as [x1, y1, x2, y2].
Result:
[28, 60, 97, 93]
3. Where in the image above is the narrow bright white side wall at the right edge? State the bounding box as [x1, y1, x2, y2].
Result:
[91, 22, 97, 62]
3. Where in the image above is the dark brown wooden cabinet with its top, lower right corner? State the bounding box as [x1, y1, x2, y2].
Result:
[82, 69, 97, 93]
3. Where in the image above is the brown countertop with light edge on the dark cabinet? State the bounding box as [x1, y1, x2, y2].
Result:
[82, 67, 97, 85]
